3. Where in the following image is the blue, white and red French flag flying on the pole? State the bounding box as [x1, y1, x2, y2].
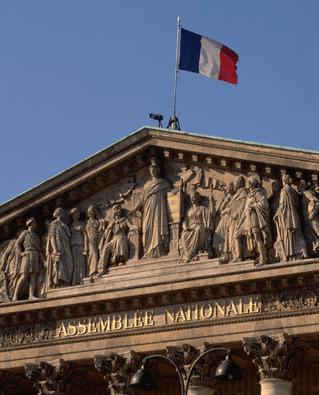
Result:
[179, 28, 238, 84]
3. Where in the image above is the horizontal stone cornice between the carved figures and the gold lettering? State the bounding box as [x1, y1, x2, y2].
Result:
[0, 259, 319, 327]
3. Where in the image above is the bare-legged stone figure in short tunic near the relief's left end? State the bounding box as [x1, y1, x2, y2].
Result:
[12, 218, 43, 302]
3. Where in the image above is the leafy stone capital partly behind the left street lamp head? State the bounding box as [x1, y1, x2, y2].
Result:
[94, 350, 143, 395]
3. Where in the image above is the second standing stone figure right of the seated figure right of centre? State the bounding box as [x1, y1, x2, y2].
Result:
[228, 176, 248, 259]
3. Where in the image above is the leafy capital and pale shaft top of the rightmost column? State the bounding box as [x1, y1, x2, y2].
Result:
[243, 333, 309, 395]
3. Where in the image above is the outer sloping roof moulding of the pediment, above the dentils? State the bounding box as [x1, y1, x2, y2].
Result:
[0, 127, 319, 222]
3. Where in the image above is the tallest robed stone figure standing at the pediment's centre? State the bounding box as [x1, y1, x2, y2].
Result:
[130, 159, 171, 258]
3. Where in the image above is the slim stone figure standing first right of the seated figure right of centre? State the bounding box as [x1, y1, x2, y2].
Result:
[213, 182, 235, 263]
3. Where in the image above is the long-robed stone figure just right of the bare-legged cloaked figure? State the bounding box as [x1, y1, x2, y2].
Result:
[274, 175, 307, 261]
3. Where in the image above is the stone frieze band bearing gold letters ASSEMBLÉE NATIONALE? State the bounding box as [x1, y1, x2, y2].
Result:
[0, 286, 319, 350]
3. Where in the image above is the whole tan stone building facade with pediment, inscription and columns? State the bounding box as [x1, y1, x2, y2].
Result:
[0, 127, 319, 395]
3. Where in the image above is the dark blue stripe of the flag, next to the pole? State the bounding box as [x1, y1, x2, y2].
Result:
[179, 28, 202, 73]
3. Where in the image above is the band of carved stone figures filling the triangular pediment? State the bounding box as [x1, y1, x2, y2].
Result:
[0, 153, 319, 303]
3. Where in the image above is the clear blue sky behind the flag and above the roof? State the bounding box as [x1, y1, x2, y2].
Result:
[0, 0, 319, 204]
